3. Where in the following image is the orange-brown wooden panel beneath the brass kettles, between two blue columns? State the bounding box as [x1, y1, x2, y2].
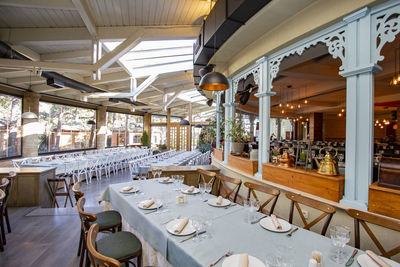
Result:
[262, 163, 344, 202]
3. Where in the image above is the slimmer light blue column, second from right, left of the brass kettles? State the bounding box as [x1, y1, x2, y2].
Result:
[255, 57, 275, 178]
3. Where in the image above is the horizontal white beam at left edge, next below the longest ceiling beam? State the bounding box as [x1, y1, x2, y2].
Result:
[0, 58, 94, 73]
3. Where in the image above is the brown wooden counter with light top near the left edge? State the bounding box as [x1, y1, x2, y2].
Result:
[0, 167, 56, 208]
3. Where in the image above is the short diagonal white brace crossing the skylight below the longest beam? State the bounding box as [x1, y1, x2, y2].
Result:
[94, 30, 143, 71]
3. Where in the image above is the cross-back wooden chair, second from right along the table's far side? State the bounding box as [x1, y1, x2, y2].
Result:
[286, 193, 336, 236]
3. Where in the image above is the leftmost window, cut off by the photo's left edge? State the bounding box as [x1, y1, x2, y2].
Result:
[0, 94, 22, 158]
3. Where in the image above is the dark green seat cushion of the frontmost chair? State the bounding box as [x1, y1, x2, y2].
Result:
[96, 232, 142, 260]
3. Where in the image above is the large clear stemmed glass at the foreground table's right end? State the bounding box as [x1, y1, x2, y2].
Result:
[330, 225, 350, 264]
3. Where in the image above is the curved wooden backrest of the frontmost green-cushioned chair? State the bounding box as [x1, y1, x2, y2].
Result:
[86, 223, 121, 267]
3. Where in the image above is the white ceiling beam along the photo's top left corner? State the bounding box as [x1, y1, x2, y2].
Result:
[0, 0, 75, 10]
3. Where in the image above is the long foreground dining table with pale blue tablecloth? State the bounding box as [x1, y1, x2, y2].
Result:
[102, 179, 364, 267]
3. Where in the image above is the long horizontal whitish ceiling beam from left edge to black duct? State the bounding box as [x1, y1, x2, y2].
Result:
[0, 25, 200, 44]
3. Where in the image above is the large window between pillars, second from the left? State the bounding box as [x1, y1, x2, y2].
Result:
[38, 102, 96, 153]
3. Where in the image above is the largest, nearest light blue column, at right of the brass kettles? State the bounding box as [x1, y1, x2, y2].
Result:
[340, 8, 381, 210]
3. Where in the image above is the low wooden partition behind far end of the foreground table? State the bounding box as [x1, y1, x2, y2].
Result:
[149, 165, 219, 186]
